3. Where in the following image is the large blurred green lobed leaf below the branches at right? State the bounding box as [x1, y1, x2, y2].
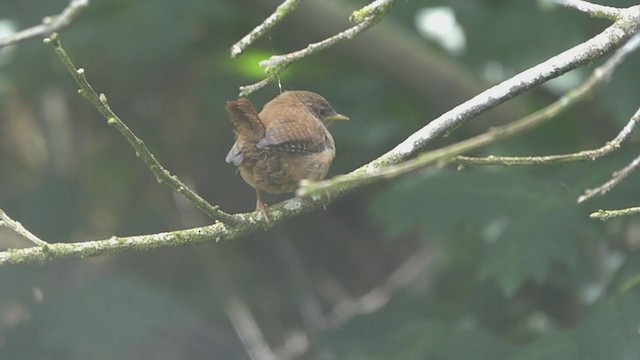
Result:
[373, 169, 589, 295]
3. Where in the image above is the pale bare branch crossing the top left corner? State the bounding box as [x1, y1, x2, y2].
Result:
[0, 0, 89, 49]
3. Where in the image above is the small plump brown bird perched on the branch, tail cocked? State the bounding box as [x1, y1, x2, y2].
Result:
[226, 91, 349, 221]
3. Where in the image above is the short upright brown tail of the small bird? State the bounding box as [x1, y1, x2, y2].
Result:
[226, 98, 265, 143]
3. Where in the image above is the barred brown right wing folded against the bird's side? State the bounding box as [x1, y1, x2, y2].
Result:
[256, 114, 326, 153]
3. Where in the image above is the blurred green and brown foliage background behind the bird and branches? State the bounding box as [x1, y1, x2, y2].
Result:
[0, 0, 640, 359]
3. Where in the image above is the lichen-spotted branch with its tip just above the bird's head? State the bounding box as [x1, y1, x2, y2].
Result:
[238, 0, 395, 96]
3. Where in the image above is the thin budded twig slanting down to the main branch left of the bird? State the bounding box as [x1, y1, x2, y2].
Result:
[45, 34, 239, 224]
